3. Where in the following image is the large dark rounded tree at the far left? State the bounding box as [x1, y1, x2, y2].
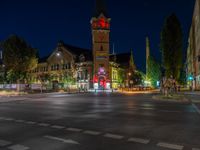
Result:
[2, 35, 38, 89]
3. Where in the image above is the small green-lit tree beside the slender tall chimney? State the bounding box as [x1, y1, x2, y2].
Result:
[147, 56, 161, 87]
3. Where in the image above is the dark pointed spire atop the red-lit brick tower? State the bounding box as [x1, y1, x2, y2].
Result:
[95, 0, 108, 17]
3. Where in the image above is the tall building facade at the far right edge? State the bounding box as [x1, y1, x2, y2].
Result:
[186, 0, 200, 89]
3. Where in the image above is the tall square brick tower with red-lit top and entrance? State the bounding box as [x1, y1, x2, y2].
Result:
[91, 0, 111, 89]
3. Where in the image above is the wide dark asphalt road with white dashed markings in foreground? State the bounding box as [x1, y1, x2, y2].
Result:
[0, 93, 200, 150]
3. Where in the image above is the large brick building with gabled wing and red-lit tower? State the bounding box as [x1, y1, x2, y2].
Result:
[29, 0, 130, 90]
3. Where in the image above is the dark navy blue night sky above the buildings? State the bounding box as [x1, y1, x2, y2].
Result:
[0, 0, 195, 70]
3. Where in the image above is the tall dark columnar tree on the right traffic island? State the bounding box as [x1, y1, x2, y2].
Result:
[160, 14, 183, 80]
